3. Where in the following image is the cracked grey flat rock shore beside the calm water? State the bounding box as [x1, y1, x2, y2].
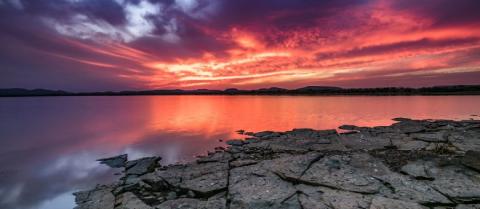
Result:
[74, 118, 480, 209]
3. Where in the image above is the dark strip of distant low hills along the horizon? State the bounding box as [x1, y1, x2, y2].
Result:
[0, 85, 480, 97]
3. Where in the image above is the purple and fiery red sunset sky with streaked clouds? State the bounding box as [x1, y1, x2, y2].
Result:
[0, 0, 480, 91]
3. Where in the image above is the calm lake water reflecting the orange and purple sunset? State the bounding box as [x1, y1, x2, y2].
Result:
[0, 96, 480, 209]
